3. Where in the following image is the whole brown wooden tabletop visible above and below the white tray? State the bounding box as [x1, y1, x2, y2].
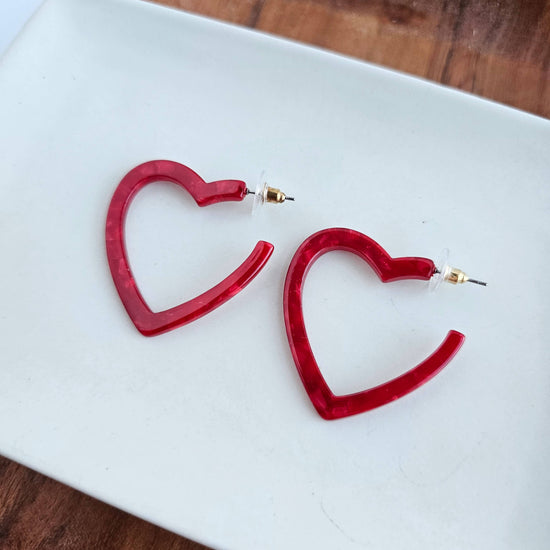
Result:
[0, 0, 550, 550]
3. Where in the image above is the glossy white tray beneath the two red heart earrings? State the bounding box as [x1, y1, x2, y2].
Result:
[0, 0, 550, 550]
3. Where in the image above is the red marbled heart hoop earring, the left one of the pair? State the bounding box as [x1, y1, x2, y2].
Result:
[105, 160, 294, 336]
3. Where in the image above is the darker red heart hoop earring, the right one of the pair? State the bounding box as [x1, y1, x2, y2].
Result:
[284, 228, 486, 420]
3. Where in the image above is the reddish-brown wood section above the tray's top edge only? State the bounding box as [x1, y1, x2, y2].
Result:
[157, 0, 550, 118]
